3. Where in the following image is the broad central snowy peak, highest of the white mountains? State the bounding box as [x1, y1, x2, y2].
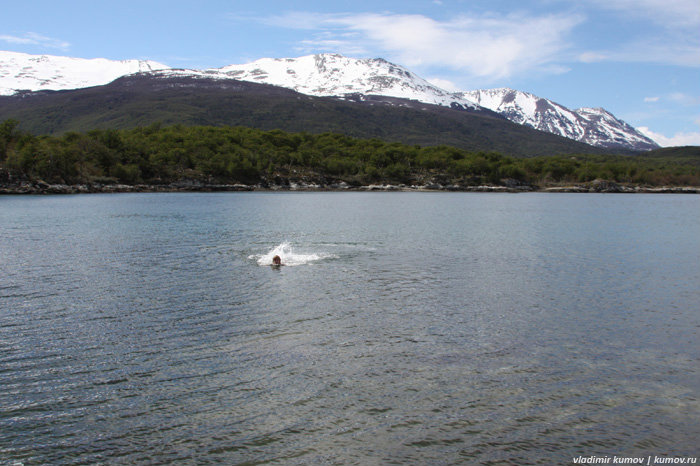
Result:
[207, 54, 478, 109]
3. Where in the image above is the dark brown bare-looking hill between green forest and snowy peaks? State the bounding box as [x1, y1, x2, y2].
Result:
[0, 71, 603, 157]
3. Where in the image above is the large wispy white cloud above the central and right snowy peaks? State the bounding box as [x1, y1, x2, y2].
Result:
[265, 12, 583, 79]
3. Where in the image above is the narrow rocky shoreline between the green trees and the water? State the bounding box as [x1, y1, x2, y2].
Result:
[0, 180, 700, 195]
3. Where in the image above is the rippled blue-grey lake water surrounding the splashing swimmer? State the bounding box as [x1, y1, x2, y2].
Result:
[0, 193, 700, 464]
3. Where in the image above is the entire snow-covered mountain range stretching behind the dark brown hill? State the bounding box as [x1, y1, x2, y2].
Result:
[0, 52, 658, 150]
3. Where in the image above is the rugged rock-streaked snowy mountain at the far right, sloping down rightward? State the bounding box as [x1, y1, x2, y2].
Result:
[461, 88, 659, 151]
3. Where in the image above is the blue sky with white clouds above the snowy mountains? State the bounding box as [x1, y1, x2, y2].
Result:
[0, 0, 700, 146]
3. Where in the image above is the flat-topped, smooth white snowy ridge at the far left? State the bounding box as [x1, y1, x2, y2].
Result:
[0, 51, 169, 95]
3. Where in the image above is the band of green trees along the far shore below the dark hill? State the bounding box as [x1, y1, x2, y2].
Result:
[0, 120, 700, 186]
